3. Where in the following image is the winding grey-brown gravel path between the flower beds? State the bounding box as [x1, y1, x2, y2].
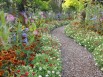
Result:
[51, 27, 103, 77]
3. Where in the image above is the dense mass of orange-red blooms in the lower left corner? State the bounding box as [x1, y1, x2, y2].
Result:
[0, 49, 25, 76]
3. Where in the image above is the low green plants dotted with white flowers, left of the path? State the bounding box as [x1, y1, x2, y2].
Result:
[16, 35, 61, 77]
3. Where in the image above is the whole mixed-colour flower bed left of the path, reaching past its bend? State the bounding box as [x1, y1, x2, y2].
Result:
[0, 12, 68, 77]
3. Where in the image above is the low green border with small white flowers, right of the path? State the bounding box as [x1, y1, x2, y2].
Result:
[65, 21, 103, 70]
